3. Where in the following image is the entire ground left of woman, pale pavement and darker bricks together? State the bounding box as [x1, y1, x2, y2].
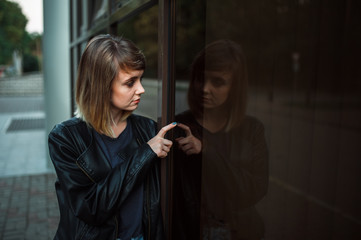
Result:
[0, 96, 59, 240]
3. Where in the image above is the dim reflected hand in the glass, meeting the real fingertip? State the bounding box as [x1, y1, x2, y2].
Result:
[176, 123, 202, 155]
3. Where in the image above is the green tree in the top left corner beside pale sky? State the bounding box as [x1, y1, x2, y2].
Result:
[0, 0, 28, 65]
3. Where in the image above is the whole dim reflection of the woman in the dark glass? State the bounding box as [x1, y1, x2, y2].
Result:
[173, 40, 268, 239]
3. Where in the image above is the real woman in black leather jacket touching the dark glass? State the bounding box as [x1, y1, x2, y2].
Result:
[48, 35, 176, 240]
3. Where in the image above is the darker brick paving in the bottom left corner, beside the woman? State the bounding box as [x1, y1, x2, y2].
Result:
[0, 174, 59, 240]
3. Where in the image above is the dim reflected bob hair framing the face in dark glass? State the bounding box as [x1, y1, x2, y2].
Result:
[188, 39, 248, 131]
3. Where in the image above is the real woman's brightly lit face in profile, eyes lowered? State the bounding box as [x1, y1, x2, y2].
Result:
[111, 67, 145, 111]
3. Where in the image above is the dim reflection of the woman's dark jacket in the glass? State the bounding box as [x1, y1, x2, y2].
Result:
[172, 111, 269, 240]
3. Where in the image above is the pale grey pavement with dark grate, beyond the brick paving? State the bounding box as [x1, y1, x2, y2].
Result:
[0, 97, 52, 177]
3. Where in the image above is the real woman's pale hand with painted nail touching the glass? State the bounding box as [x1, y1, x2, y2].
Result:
[147, 122, 177, 158]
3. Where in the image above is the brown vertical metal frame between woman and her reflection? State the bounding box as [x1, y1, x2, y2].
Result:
[158, 0, 176, 236]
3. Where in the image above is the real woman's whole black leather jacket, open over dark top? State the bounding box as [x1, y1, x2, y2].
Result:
[48, 114, 164, 240]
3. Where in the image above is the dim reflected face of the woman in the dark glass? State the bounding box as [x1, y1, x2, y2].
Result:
[202, 71, 232, 109]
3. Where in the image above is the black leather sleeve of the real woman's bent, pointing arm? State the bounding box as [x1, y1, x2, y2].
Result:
[48, 123, 156, 225]
